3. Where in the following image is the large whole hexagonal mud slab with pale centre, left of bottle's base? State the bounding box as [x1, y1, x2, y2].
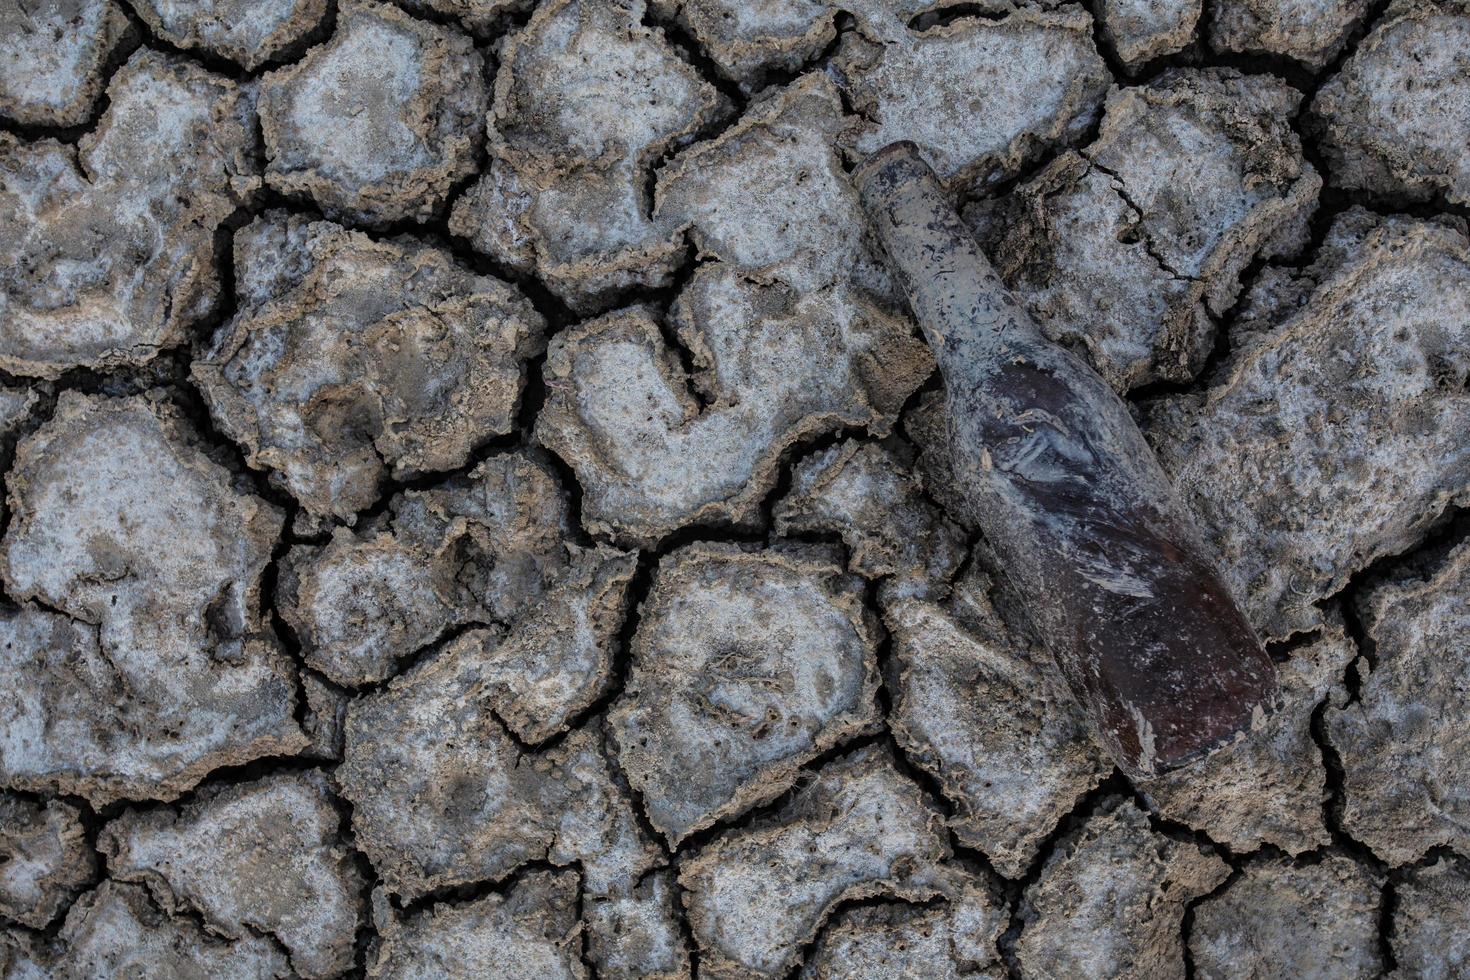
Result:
[609, 544, 878, 846]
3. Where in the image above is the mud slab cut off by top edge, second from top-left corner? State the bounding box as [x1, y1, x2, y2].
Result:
[132, 0, 328, 72]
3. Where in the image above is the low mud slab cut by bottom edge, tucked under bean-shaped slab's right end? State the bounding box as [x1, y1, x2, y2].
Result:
[801, 882, 1007, 980]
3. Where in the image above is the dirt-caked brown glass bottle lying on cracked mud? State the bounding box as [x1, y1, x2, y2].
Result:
[854, 143, 1276, 777]
